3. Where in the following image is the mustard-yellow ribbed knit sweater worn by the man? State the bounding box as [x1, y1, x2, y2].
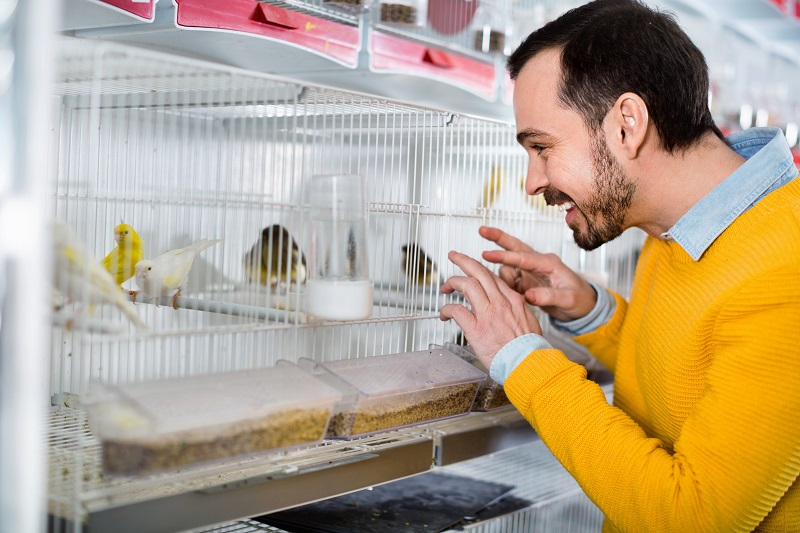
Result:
[505, 179, 800, 533]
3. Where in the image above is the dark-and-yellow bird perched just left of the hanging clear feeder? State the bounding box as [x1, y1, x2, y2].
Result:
[243, 224, 307, 288]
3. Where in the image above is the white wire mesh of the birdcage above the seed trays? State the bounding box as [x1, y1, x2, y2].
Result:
[48, 39, 642, 528]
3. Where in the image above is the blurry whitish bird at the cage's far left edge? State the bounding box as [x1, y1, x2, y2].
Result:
[53, 221, 147, 328]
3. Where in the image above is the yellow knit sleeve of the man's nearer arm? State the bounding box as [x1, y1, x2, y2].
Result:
[505, 269, 800, 533]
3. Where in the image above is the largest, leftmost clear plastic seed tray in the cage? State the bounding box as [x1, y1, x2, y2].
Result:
[81, 363, 341, 474]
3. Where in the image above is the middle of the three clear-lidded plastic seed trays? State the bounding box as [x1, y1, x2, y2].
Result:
[301, 350, 486, 438]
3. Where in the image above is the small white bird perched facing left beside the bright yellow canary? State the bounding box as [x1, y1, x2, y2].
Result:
[136, 239, 221, 309]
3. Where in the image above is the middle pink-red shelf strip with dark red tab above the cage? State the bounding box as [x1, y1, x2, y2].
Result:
[177, 0, 359, 67]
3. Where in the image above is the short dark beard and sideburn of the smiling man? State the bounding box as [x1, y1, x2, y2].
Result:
[543, 132, 636, 251]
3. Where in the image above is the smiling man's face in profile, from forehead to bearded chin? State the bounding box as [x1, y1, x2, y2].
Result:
[514, 50, 636, 250]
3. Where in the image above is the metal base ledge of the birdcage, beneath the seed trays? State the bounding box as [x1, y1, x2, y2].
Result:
[48, 407, 548, 533]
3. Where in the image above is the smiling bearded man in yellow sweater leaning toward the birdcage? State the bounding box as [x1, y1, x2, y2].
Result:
[440, 0, 800, 533]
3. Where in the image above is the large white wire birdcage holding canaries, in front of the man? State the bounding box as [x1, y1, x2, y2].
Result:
[42, 39, 641, 532]
